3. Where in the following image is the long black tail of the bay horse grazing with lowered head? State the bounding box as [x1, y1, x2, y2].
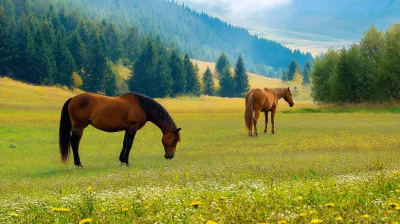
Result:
[58, 98, 72, 163]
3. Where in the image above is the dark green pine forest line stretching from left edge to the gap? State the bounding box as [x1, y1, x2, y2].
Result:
[0, 0, 248, 97]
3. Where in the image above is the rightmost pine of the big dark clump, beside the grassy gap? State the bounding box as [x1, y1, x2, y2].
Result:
[183, 54, 200, 96]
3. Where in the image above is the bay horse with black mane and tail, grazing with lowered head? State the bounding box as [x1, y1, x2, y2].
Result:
[59, 93, 181, 167]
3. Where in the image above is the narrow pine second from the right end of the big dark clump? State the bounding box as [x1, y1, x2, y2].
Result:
[169, 49, 186, 96]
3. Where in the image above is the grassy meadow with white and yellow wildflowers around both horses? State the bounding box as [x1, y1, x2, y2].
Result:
[0, 77, 400, 224]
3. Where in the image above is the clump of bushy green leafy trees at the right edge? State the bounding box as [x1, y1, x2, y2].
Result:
[311, 24, 400, 103]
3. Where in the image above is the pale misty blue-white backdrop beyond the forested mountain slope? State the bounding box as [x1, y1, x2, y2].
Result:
[178, 0, 400, 55]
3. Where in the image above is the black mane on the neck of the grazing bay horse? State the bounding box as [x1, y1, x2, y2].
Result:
[132, 93, 176, 132]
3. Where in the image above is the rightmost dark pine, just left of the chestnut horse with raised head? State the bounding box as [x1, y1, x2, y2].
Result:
[234, 54, 250, 97]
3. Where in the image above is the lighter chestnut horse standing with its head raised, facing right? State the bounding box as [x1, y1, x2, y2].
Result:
[244, 87, 294, 136]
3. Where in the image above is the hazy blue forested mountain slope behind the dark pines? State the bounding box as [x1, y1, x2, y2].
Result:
[53, 0, 313, 77]
